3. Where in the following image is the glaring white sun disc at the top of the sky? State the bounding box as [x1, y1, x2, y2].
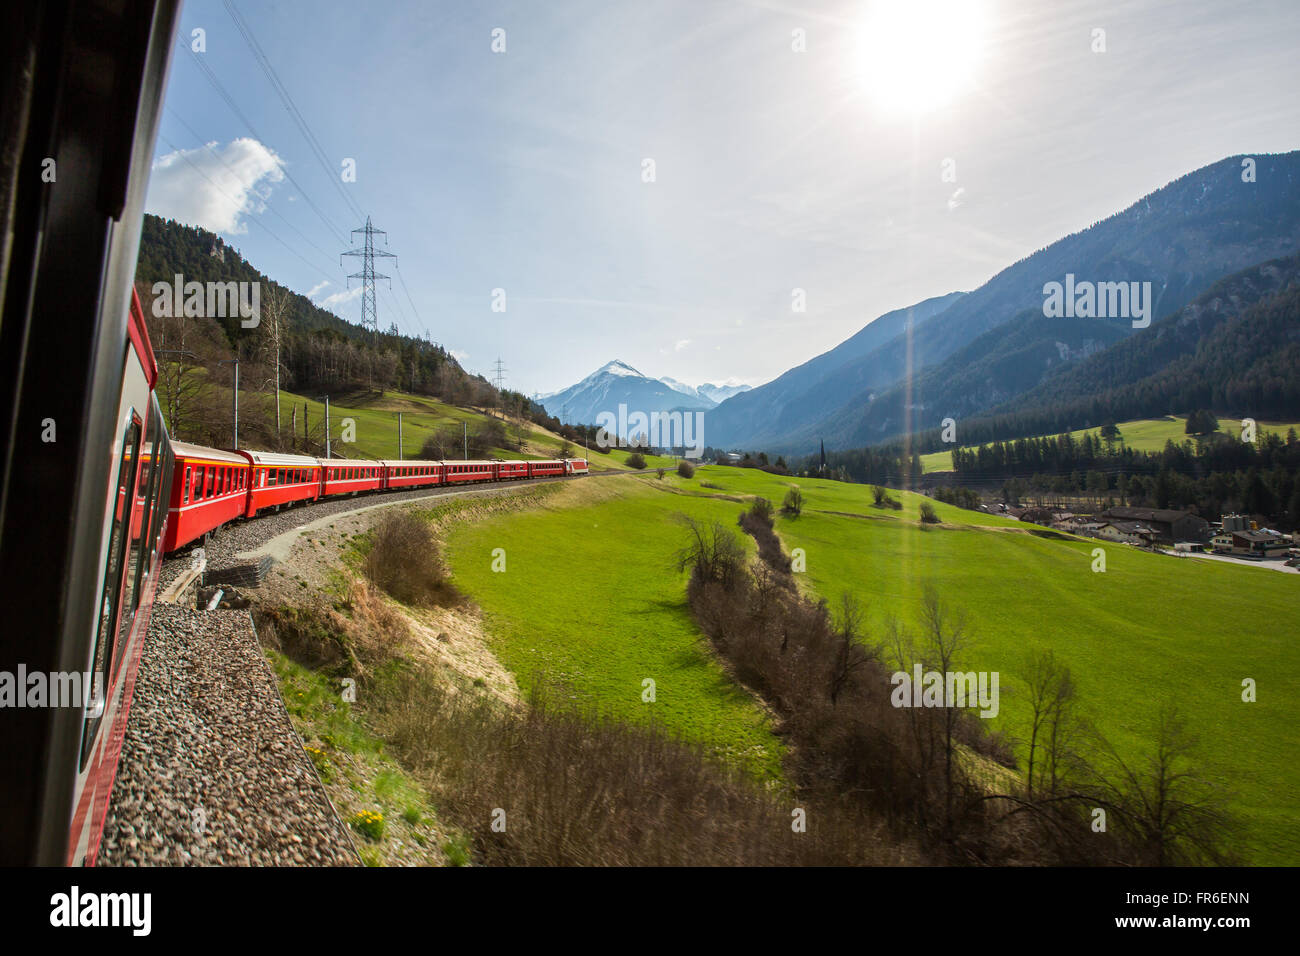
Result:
[858, 0, 988, 116]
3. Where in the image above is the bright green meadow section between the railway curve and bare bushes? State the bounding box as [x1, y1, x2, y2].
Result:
[446, 479, 781, 779]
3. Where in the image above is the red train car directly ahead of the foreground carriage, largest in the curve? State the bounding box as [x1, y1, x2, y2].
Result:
[163, 441, 250, 553]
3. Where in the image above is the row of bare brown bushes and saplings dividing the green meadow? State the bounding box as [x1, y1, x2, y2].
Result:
[677, 512, 1234, 865]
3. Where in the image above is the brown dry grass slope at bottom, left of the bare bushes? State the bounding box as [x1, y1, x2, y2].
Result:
[368, 670, 917, 866]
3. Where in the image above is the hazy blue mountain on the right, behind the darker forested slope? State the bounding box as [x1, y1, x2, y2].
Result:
[705, 152, 1300, 451]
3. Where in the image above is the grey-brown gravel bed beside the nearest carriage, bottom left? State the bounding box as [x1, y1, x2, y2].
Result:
[99, 604, 359, 866]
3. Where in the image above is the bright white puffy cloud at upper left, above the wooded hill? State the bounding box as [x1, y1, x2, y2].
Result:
[146, 138, 285, 235]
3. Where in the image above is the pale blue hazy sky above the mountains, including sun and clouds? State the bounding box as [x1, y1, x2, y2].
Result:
[146, 0, 1300, 394]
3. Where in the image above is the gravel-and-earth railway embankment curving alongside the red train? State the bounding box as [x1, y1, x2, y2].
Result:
[99, 479, 564, 866]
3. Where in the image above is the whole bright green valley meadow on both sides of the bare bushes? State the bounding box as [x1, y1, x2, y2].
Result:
[449, 467, 1300, 864]
